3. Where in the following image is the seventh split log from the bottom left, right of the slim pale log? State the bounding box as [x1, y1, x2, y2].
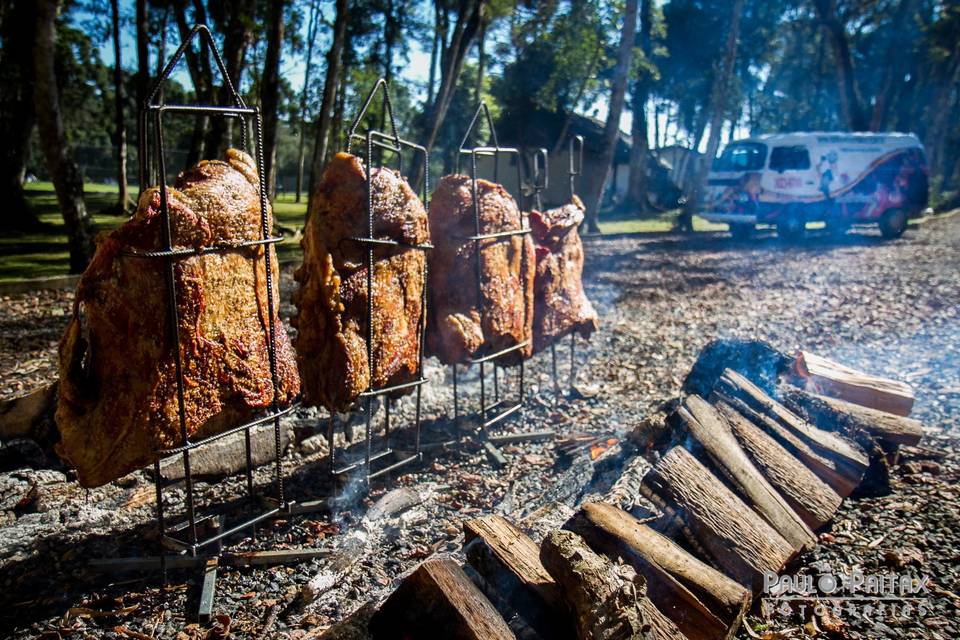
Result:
[716, 401, 843, 531]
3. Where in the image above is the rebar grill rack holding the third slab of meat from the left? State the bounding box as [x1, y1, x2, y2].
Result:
[451, 102, 530, 437]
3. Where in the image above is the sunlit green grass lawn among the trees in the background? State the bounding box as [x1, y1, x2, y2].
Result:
[0, 182, 725, 283]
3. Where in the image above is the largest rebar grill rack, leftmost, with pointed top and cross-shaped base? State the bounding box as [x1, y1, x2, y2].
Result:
[91, 24, 326, 622]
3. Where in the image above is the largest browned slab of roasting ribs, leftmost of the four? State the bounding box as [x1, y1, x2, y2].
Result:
[56, 149, 300, 487]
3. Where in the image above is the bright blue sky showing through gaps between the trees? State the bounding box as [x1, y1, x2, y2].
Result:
[90, 0, 748, 152]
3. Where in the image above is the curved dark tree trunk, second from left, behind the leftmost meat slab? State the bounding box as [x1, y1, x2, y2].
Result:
[33, 0, 93, 273]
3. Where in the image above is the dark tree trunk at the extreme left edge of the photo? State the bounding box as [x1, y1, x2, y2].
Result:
[0, 0, 41, 230]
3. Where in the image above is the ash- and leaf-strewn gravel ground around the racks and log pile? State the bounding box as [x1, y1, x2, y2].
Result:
[0, 217, 960, 638]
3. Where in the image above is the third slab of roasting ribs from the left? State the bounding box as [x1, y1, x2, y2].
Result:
[427, 174, 534, 364]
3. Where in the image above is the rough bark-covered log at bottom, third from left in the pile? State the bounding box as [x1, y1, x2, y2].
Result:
[540, 531, 684, 640]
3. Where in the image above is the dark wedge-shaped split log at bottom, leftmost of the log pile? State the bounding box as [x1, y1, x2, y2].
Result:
[370, 558, 515, 640]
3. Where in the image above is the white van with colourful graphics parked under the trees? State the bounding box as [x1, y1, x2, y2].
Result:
[700, 132, 927, 240]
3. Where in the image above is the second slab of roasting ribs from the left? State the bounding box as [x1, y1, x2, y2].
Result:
[294, 153, 430, 411]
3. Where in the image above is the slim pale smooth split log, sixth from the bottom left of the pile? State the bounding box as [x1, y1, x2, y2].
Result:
[676, 395, 817, 551]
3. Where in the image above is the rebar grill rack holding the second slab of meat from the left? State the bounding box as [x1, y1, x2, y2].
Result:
[327, 78, 433, 483]
